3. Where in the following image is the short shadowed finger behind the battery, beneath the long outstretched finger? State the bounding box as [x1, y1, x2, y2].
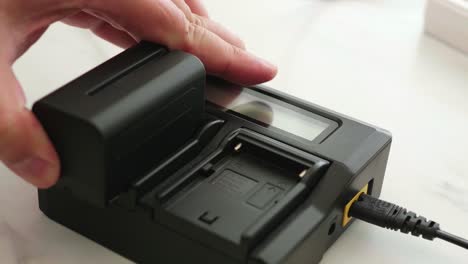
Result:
[62, 12, 137, 49]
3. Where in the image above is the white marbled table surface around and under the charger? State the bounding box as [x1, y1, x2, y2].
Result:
[0, 0, 468, 264]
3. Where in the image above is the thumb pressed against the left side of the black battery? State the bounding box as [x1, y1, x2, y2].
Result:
[0, 64, 60, 188]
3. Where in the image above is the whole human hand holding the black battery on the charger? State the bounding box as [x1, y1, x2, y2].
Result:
[0, 0, 276, 188]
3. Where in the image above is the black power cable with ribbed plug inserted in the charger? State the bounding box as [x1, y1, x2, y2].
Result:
[349, 194, 468, 249]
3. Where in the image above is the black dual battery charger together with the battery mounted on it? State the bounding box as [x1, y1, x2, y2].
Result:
[33, 42, 391, 264]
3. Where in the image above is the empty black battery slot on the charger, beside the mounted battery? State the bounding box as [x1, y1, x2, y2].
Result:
[153, 130, 328, 256]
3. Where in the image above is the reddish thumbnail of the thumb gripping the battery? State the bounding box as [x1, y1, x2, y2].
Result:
[8, 157, 53, 188]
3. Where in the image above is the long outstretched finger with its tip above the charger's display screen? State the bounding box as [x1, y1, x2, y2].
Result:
[89, 0, 276, 84]
